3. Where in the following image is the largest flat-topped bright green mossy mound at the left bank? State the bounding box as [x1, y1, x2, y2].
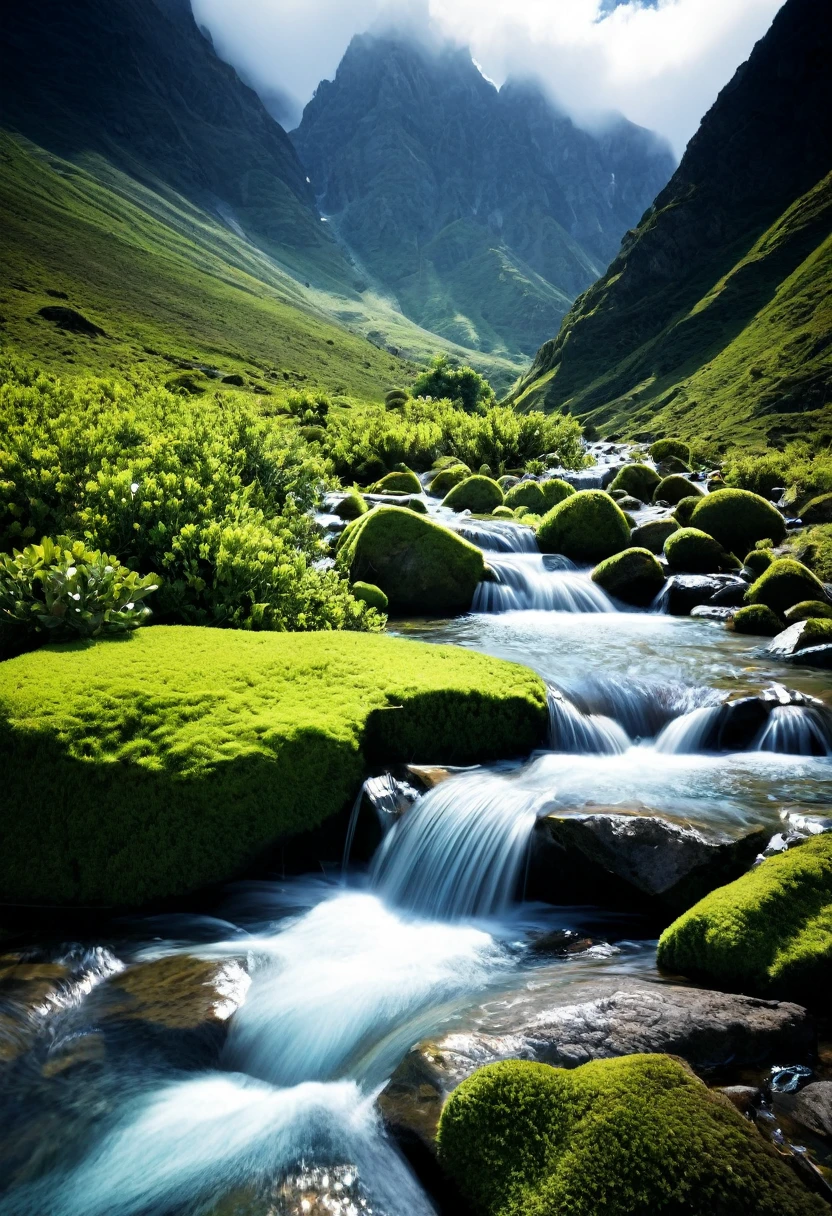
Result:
[0, 632, 546, 905]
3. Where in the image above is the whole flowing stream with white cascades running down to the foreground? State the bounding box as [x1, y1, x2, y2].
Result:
[0, 488, 832, 1216]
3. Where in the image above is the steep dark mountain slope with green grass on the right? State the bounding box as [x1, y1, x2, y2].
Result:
[512, 0, 832, 443]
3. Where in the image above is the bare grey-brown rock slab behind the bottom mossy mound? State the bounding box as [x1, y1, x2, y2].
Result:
[378, 979, 812, 1145]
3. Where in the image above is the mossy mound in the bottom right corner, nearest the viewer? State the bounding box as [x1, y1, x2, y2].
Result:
[438, 1055, 826, 1216]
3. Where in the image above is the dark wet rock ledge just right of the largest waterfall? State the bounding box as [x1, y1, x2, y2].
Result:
[527, 806, 768, 911]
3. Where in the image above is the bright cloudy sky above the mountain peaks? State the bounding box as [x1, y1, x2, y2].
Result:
[192, 0, 782, 156]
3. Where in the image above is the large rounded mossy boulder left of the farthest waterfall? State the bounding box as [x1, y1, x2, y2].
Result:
[338, 507, 485, 617]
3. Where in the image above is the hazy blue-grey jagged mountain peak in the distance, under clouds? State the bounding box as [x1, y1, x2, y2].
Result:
[292, 34, 674, 355]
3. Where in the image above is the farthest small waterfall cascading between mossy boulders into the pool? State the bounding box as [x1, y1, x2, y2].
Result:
[472, 553, 615, 613]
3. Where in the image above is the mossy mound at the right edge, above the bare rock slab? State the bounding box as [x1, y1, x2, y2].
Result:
[658, 833, 832, 1004]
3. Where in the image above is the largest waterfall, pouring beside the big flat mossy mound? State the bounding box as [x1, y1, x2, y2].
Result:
[372, 771, 541, 919]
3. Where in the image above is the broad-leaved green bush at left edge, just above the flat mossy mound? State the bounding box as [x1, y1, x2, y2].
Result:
[0, 536, 158, 655]
